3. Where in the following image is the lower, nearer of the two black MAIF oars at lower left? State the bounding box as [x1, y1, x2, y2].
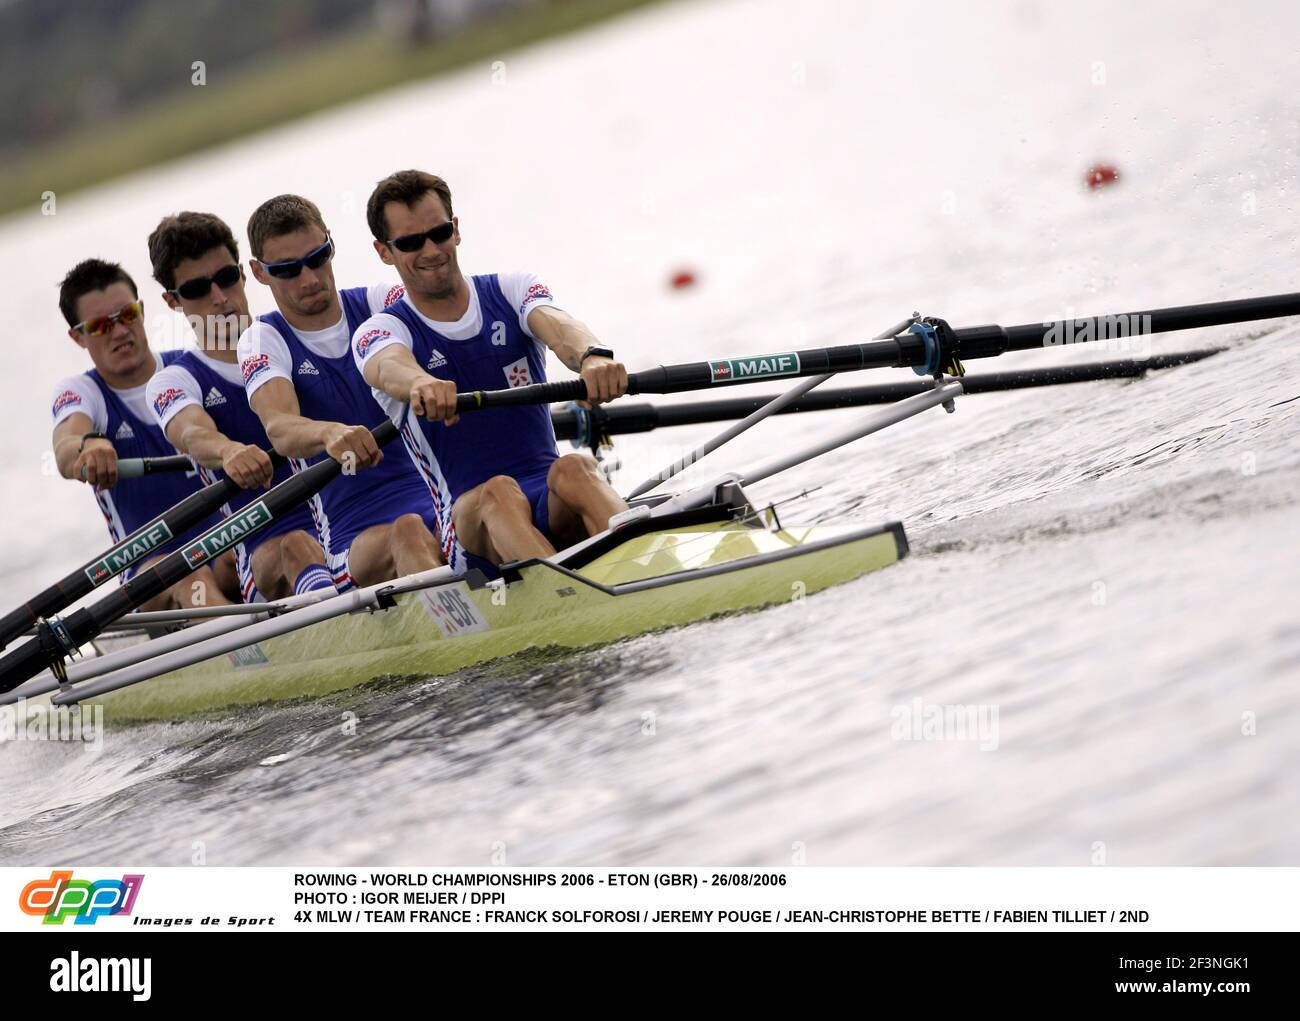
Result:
[0, 421, 398, 692]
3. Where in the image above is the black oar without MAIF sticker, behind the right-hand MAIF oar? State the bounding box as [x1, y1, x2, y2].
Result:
[551, 347, 1223, 444]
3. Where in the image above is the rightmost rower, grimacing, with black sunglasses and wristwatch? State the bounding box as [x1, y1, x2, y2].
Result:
[352, 170, 628, 563]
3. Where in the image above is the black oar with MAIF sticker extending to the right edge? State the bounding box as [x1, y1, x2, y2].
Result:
[456, 294, 1300, 414]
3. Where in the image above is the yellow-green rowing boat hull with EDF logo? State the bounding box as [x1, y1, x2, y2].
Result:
[90, 522, 907, 721]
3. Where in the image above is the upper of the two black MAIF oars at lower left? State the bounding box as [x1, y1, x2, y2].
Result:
[0, 450, 285, 649]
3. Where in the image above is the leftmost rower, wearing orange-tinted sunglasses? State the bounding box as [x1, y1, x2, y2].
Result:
[53, 259, 239, 610]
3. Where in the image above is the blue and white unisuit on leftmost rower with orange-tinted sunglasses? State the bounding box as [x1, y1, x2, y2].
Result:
[52, 351, 221, 581]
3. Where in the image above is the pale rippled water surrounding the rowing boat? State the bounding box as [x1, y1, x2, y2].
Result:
[0, 3, 1300, 865]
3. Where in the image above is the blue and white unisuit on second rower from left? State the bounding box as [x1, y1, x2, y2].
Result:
[146, 351, 332, 602]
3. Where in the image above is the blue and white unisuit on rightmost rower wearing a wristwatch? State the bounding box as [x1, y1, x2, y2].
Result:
[352, 273, 559, 538]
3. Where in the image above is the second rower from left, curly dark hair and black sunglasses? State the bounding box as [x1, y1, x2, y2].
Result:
[146, 212, 334, 602]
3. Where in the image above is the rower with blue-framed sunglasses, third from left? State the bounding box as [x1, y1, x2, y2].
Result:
[238, 195, 443, 590]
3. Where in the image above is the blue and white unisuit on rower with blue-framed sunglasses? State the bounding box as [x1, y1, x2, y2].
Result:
[232, 285, 436, 589]
